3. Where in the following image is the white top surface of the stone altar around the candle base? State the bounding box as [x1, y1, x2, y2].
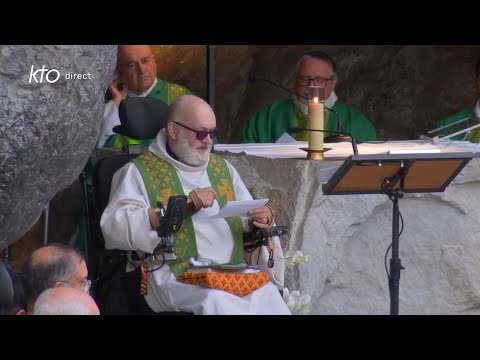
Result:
[215, 140, 480, 160]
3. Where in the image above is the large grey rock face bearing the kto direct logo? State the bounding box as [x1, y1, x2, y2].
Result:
[0, 45, 117, 250]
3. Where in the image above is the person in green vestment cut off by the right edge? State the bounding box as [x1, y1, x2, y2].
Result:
[435, 57, 480, 143]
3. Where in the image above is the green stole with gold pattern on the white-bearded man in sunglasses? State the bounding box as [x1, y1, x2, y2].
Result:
[133, 151, 243, 275]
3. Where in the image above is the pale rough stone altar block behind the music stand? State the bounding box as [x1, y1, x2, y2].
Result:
[225, 155, 480, 314]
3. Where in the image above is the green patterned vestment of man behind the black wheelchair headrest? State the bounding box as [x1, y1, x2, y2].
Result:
[103, 79, 191, 148]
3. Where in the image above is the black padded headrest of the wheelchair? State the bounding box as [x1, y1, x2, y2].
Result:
[113, 97, 168, 140]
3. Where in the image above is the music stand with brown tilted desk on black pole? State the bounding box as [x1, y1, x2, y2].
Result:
[322, 152, 473, 315]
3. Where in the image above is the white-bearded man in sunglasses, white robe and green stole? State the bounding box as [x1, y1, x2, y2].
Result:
[100, 95, 290, 315]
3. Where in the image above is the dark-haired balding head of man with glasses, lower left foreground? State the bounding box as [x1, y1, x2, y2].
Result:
[22, 243, 91, 314]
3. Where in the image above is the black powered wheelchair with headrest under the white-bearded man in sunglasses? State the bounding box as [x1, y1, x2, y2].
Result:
[84, 97, 288, 315]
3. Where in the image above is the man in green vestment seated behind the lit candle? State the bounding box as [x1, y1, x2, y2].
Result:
[240, 51, 377, 143]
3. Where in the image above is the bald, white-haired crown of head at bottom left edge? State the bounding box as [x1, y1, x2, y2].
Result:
[33, 287, 100, 315]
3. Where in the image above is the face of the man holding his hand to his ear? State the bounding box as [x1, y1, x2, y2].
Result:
[117, 45, 157, 95]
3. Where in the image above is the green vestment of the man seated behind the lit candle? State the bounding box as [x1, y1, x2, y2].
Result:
[240, 99, 377, 143]
